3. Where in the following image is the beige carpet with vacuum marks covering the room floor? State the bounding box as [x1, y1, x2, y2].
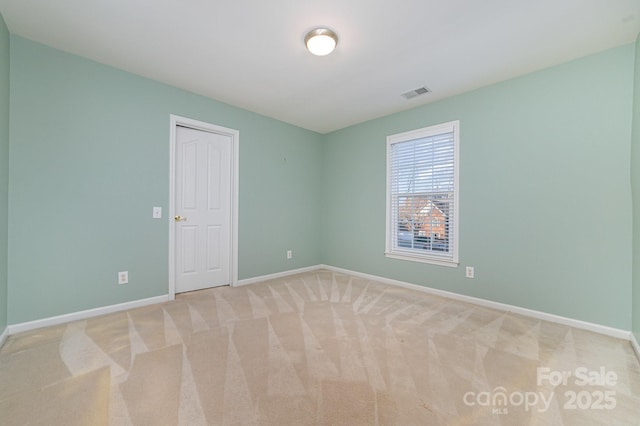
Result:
[0, 271, 640, 426]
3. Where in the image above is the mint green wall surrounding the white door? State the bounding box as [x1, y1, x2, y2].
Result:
[8, 36, 322, 324]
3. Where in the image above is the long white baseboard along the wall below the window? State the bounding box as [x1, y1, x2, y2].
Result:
[320, 265, 632, 340]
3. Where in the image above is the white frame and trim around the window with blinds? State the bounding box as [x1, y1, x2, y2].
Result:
[385, 120, 460, 267]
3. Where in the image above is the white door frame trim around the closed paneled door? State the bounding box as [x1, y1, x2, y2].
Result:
[168, 114, 240, 300]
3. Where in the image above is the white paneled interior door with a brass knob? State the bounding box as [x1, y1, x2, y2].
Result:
[174, 126, 232, 293]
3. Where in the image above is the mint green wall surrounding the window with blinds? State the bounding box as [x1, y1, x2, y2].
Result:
[322, 45, 634, 330]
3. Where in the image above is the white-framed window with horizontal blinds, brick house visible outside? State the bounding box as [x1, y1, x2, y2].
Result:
[386, 121, 460, 266]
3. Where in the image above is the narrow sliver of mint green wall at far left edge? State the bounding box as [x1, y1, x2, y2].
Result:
[0, 15, 9, 333]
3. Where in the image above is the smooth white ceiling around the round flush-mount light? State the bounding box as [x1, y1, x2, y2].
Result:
[0, 0, 640, 133]
